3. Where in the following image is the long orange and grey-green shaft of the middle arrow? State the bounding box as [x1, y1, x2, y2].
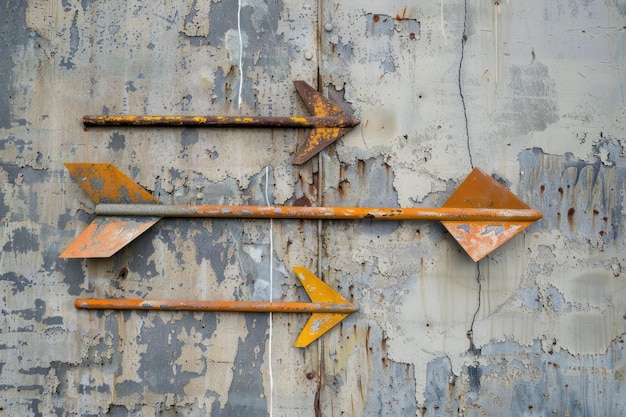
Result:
[96, 204, 541, 222]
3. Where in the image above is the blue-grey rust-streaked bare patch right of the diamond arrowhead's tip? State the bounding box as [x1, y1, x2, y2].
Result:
[519, 138, 626, 244]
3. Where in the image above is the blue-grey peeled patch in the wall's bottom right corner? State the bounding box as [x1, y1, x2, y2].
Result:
[477, 337, 624, 415]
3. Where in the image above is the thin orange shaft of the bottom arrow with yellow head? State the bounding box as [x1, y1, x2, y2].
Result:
[74, 298, 358, 314]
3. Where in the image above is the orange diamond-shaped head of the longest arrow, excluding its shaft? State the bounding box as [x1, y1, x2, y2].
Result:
[442, 168, 533, 262]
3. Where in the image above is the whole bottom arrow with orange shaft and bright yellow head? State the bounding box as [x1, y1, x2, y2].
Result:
[74, 266, 358, 348]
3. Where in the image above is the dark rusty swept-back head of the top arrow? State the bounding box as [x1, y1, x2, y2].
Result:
[293, 81, 359, 165]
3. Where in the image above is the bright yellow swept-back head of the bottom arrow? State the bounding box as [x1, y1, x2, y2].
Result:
[293, 266, 356, 347]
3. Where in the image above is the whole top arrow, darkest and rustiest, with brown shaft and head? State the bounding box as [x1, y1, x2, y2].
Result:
[83, 81, 359, 165]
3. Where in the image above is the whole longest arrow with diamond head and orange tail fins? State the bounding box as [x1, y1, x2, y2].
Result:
[60, 163, 542, 261]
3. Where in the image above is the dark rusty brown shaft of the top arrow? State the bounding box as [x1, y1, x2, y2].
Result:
[83, 115, 358, 127]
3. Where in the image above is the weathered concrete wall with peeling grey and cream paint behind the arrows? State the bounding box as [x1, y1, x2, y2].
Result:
[0, 0, 626, 416]
